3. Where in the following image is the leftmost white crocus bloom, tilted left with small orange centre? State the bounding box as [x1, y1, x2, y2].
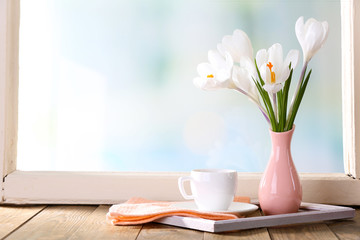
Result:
[194, 50, 235, 90]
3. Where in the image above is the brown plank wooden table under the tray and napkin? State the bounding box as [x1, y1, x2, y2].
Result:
[0, 205, 360, 240]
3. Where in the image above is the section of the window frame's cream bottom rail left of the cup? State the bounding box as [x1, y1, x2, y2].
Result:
[4, 171, 186, 204]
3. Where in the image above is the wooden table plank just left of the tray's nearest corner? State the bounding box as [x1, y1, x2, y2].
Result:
[136, 223, 204, 240]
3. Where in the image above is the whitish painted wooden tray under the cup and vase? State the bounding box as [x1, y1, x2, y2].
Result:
[156, 203, 355, 232]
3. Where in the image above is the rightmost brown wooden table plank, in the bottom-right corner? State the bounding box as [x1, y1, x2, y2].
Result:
[327, 208, 360, 240]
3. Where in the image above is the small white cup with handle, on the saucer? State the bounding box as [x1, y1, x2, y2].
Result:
[178, 169, 237, 211]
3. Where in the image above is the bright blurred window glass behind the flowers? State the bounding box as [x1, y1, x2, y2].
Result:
[18, 0, 343, 172]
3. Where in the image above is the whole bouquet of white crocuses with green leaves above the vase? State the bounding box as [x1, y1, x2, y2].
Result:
[194, 17, 328, 132]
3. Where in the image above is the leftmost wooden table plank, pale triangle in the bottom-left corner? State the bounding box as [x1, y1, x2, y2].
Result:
[0, 206, 46, 239]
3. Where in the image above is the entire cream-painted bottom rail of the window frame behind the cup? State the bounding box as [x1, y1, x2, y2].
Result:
[4, 171, 360, 205]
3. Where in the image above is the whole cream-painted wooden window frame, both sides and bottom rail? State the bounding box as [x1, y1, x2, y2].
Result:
[0, 0, 360, 205]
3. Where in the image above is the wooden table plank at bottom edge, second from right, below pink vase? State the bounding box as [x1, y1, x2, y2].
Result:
[268, 223, 338, 240]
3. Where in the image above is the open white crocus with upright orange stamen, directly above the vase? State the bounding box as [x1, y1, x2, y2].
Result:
[256, 43, 299, 94]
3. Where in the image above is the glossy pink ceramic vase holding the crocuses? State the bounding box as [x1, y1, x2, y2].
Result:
[259, 126, 302, 215]
